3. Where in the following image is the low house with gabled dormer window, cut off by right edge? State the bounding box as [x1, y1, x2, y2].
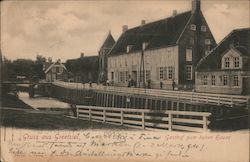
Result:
[195, 28, 250, 95]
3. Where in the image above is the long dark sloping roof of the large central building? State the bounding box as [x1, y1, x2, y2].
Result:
[109, 11, 192, 56]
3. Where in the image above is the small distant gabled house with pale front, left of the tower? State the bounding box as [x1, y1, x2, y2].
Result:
[45, 60, 68, 82]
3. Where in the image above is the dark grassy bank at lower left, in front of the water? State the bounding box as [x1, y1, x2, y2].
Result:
[0, 95, 131, 130]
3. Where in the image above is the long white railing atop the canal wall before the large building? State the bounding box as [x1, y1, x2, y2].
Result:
[53, 82, 250, 107]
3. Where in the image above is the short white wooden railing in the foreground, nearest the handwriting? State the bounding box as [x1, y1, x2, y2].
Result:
[76, 105, 211, 132]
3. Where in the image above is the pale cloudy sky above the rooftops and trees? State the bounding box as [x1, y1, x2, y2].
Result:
[1, 0, 250, 61]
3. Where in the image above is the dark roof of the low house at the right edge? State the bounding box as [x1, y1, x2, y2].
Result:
[196, 28, 250, 71]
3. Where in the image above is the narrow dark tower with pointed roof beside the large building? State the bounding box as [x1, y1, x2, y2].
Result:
[98, 32, 115, 83]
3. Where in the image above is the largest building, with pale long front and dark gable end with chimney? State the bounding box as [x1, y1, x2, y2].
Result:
[108, 0, 216, 89]
